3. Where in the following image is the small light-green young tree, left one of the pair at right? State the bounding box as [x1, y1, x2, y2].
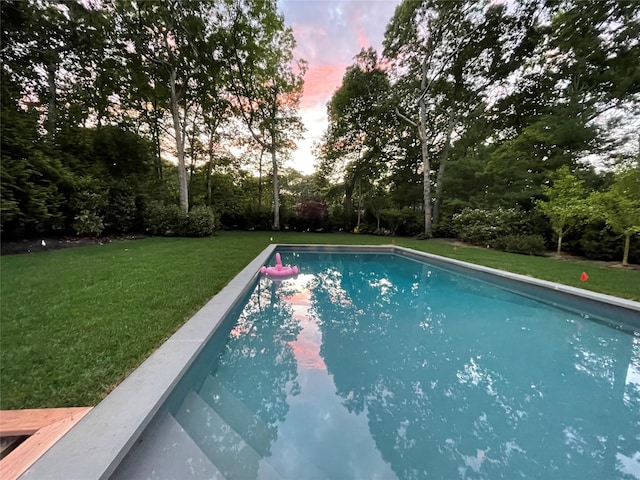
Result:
[537, 165, 587, 256]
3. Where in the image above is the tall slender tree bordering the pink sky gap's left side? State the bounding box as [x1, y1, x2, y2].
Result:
[225, 0, 306, 230]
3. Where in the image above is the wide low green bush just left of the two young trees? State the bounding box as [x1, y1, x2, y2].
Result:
[452, 207, 530, 245]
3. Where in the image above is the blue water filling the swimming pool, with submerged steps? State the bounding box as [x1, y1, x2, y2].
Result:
[115, 252, 640, 480]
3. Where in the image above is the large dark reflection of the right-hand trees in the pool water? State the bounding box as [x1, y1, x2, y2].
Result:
[310, 255, 640, 479]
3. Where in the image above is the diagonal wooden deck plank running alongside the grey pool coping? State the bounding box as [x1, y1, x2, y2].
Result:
[0, 407, 91, 480]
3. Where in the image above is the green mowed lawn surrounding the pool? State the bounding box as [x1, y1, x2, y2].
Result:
[0, 232, 640, 409]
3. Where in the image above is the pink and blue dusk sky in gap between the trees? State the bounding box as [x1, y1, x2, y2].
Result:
[278, 0, 400, 174]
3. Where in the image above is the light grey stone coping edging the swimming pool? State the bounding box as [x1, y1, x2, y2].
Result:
[20, 244, 640, 479]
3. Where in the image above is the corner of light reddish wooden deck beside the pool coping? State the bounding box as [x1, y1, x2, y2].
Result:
[0, 407, 91, 480]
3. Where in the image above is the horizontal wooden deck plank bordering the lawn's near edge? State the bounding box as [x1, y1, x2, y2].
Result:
[0, 407, 91, 437]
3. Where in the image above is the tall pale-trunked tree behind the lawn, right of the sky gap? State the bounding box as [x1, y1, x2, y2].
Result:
[384, 0, 531, 237]
